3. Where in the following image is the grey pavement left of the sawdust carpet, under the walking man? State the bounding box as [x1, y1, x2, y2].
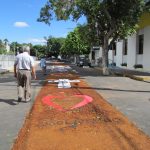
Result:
[0, 65, 45, 150]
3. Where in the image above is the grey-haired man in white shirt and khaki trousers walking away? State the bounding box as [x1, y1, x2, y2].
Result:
[14, 46, 36, 102]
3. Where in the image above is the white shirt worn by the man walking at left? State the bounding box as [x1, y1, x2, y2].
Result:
[15, 52, 34, 70]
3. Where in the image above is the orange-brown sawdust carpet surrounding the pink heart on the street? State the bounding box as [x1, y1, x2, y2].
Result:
[12, 66, 150, 150]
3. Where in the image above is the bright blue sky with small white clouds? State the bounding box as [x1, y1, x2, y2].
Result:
[0, 0, 85, 44]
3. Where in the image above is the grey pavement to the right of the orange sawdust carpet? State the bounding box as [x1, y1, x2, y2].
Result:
[72, 66, 150, 136]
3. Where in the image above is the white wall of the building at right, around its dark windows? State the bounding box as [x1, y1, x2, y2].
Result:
[109, 26, 150, 71]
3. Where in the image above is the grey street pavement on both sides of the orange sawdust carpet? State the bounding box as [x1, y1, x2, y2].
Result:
[0, 62, 150, 150]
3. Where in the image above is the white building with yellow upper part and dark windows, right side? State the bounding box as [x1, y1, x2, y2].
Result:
[90, 13, 150, 71]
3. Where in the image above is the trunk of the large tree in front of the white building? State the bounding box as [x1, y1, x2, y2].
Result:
[102, 38, 109, 75]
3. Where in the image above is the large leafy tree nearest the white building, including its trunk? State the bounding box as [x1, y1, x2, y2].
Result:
[38, 0, 145, 74]
